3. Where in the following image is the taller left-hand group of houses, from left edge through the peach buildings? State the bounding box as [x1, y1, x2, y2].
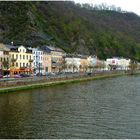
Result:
[0, 44, 65, 74]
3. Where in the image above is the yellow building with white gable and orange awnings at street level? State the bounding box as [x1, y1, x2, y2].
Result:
[6, 45, 33, 75]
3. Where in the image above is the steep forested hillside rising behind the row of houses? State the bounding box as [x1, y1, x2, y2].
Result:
[0, 1, 140, 60]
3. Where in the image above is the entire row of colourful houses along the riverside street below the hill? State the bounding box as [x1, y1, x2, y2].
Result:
[0, 43, 130, 75]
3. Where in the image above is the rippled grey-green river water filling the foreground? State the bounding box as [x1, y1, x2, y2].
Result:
[0, 76, 140, 139]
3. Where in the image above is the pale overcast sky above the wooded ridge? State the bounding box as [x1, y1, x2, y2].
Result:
[74, 0, 140, 15]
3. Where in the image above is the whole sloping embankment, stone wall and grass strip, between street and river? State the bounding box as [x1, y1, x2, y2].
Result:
[0, 71, 129, 93]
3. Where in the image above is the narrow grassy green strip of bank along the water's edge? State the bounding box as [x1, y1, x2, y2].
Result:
[0, 73, 126, 93]
